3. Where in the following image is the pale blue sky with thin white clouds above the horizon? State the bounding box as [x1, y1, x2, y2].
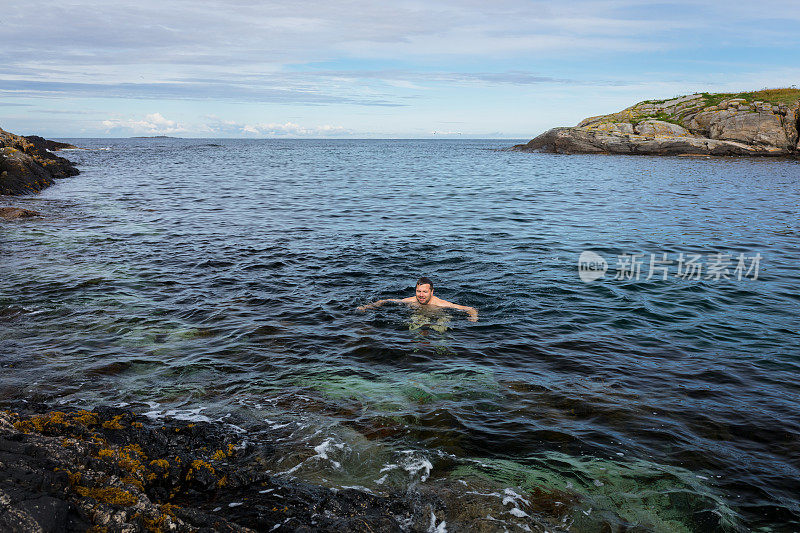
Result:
[0, 0, 800, 139]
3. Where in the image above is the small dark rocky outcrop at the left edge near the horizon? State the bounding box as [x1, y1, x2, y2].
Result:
[0, 129, 78, 195]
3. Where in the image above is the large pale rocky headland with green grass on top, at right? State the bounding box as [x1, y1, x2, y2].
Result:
[512, 89, 800, 157]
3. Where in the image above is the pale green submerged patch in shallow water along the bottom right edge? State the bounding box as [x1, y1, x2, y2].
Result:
[451, 452, 743, 533]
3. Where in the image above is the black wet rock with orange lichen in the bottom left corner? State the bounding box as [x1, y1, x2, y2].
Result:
[0, 407, 422, 532]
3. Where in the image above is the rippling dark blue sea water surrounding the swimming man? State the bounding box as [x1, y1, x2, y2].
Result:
[0, 139, 800, 531]
